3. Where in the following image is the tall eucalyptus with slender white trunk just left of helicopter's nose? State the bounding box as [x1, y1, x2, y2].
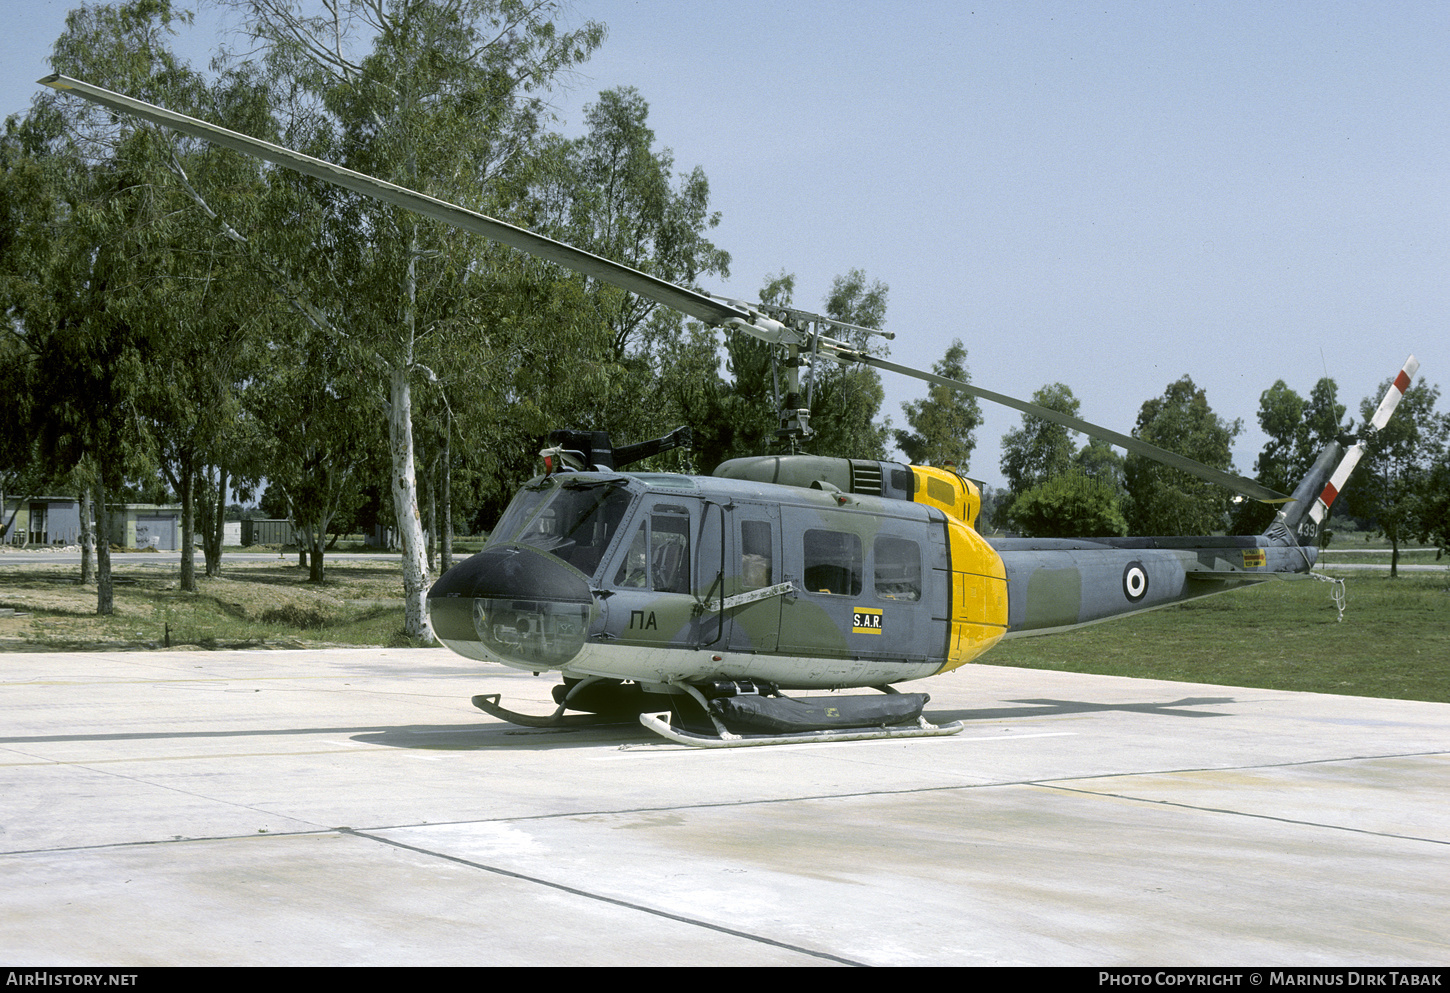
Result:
[227, 0, 603, 639]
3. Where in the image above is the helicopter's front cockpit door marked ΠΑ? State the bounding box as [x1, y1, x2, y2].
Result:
[602, 494, 722, 648]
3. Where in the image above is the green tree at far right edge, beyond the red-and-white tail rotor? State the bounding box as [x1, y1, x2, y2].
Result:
[1343, 378, 1450, 578]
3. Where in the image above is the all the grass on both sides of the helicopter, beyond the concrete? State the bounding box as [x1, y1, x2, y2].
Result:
[0, 555, 1450, 702]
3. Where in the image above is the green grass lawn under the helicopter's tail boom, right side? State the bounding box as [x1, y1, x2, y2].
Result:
[982, 568, 1450, 703]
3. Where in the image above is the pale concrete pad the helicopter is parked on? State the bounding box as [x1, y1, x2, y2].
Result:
[0, 649, 1450, 965]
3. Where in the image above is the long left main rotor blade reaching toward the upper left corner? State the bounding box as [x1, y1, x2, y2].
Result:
[38, 74, 754, 325]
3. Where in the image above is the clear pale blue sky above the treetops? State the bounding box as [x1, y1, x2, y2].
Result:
[0, 0, 1450, 484]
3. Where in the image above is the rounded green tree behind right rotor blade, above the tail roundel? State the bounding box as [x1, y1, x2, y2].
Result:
[1124, 375, 1243, 535]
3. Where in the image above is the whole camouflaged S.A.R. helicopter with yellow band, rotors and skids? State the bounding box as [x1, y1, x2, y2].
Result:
[41, 75, 1418, 747]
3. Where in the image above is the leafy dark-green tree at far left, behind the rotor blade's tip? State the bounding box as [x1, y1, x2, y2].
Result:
[6, 0, 214, 613]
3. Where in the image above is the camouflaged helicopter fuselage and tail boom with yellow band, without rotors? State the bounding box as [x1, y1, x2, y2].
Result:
[429, 457, 1317, 689]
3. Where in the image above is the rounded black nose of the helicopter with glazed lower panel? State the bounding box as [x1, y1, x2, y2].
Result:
[428, 545, 595, 671]
